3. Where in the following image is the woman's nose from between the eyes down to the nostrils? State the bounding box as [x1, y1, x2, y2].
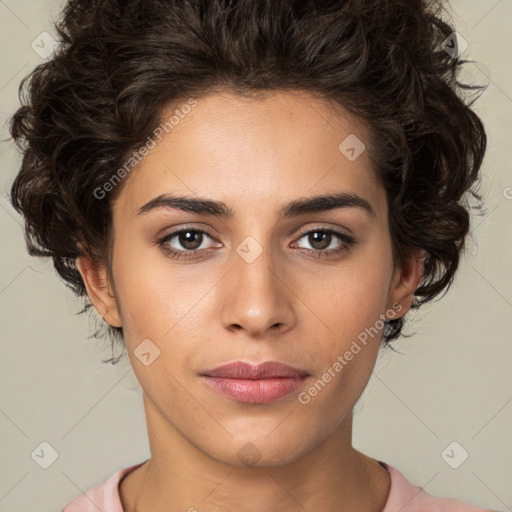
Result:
[222, 231, 293, 335]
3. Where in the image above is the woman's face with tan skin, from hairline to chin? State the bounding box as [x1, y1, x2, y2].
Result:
[80, 92, 420, 465]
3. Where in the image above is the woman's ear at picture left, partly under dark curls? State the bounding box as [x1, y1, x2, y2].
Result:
[76, 251, 122, 327]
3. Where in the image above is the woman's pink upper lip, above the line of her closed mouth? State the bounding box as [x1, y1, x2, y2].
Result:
[201, 361, 309, 379]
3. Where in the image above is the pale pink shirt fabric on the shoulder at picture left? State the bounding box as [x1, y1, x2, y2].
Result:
[62, 462, 144, 512]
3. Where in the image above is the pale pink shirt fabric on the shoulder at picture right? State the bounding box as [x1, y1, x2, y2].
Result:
[378, 461, 498, 512]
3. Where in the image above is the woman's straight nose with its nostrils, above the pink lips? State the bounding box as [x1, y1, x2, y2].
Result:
[222, 238, 296, 339]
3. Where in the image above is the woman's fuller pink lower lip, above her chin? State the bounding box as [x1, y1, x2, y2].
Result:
[200, 375, 307, 404]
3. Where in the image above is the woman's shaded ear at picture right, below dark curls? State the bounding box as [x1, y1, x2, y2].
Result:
[387, 249, 425, 318]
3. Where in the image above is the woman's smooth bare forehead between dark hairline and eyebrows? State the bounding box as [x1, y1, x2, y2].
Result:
[112, 91, 383, 220]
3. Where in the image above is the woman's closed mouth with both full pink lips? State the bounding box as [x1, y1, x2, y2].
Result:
[200, 361, 310, 404]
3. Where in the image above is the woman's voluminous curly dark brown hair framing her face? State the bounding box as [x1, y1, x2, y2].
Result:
[10, 0, 486, 361]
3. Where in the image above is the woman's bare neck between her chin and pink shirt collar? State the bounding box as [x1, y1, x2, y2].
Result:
[119, 396, 390, 512]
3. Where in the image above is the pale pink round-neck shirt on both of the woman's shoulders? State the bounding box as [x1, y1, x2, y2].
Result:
[62, 461, 498, 512]
